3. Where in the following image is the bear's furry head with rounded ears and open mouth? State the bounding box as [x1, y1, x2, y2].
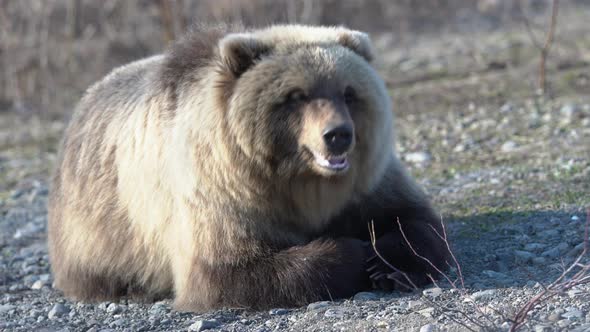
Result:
[218, 25, 393, 197]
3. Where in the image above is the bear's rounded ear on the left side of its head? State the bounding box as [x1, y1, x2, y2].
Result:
[219, 33, 270, 77]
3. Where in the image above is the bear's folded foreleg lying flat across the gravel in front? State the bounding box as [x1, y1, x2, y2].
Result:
[175, 238, 370, 311]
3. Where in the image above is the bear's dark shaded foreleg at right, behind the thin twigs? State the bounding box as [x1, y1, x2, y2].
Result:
[328, 165, 449, 290]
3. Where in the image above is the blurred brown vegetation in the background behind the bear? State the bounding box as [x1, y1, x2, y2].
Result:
[0, 0, 588, 115]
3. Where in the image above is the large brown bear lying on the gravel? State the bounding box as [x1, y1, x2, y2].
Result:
[49, 25, 446, 311]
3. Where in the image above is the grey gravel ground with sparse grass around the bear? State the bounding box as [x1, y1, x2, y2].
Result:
[0, 8, 590, 332]
